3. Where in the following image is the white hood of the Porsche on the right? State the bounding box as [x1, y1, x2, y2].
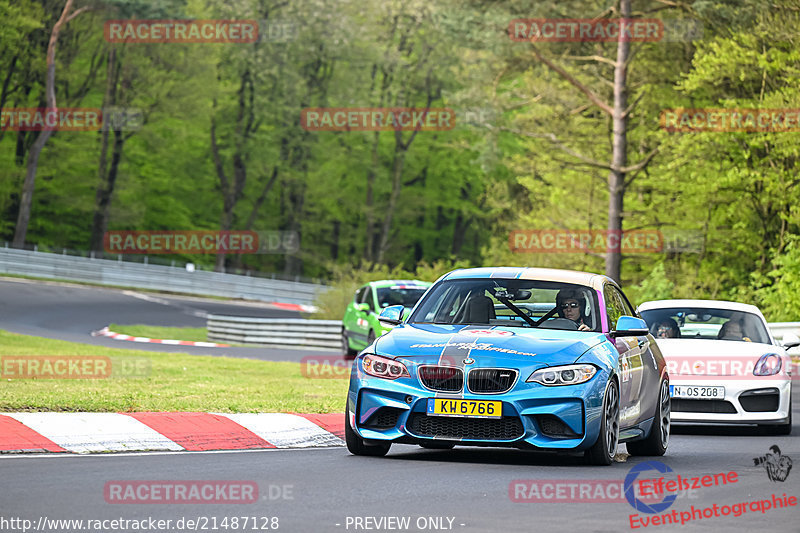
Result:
[656, 339, 784, 376]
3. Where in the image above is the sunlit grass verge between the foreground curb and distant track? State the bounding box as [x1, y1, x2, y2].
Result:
[0, 330, 347, 413]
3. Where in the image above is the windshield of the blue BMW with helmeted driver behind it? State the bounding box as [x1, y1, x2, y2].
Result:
[408, 278, 600, 331]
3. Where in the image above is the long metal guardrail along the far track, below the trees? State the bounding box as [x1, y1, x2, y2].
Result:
[0, 247, 327, 305]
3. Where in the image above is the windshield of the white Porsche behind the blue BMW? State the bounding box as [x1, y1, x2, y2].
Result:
[641, 307, 770, 344]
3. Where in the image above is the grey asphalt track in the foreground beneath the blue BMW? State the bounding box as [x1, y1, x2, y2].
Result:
[0, 391, 800, 533]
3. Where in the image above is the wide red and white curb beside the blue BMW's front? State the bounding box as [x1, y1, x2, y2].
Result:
[0, 412, 344, 453]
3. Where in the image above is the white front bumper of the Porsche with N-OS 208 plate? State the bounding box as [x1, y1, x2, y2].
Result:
[671, 376, 792, 424]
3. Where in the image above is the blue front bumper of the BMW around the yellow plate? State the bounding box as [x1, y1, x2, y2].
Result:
[348, 358, 609, 451]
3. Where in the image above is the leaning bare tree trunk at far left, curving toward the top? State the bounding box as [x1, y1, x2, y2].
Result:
[12, 0, 86, 248]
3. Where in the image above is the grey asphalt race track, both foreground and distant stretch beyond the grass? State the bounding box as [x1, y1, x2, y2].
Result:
[0, 281, 800, 533]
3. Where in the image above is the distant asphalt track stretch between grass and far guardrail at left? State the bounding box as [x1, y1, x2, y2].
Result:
[0, 278, 331, 362]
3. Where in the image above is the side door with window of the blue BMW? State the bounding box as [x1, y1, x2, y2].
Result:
[603, 283, 648, 428]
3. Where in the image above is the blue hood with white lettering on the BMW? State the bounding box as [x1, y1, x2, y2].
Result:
[375, 324, 606, 366]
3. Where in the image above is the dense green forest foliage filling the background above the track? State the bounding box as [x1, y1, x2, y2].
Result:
[0, 0, 800, 320]
